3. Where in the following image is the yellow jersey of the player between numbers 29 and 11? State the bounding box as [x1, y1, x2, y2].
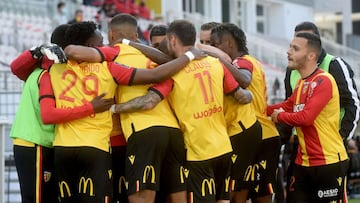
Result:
[115, 44, 179, 140]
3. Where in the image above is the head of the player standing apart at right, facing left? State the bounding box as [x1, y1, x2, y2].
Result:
[287, 32, 321, 69]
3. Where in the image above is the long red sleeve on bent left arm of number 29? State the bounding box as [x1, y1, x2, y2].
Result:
[39, 71, 94, 124]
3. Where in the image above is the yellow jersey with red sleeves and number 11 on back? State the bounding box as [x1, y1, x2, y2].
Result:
[153, 57, 239, 161]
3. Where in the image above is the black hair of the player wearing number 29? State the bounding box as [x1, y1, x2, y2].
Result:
[65, 21, 97, 46]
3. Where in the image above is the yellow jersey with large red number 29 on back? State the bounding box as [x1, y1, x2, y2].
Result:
[50, 61, 135, 151]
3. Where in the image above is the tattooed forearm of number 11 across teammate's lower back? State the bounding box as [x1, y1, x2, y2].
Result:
[115, 91, 162, 113]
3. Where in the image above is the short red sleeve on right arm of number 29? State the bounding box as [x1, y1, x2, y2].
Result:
[107, 62, 136, 86]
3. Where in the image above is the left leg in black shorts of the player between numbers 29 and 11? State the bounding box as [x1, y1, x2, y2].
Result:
[125, 126, 168, 203]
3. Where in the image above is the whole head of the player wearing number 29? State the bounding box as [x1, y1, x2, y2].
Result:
[65, 21, 103, 47]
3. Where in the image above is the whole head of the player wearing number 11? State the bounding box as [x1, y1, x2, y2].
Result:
[166, 20, 196, 57]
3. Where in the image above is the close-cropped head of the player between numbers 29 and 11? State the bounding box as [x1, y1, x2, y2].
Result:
[108, 14, 138, 44]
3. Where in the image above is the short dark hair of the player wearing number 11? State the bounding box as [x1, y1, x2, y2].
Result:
[166, 20, 196, 46]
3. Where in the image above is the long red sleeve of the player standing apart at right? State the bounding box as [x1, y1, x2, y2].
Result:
[278, 76, 333, 126]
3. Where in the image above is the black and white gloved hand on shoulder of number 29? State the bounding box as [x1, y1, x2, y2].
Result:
[40, 43, 67, 63]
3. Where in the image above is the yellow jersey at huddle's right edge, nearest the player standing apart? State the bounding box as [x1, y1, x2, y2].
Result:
[233, 55, 279, 140]
